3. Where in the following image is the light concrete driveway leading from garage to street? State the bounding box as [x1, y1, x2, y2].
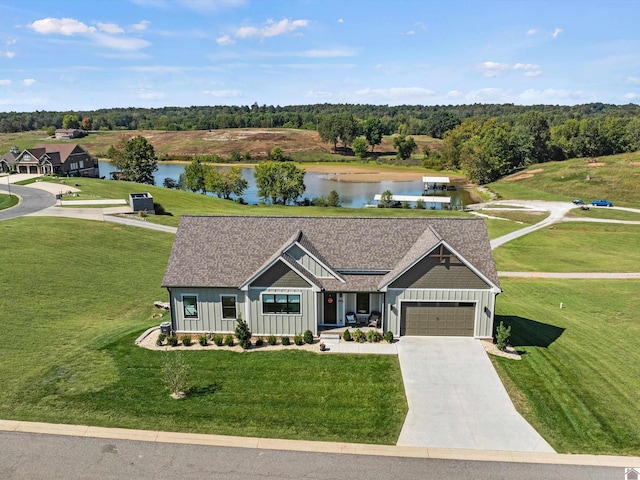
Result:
[397, 337, 554, 452]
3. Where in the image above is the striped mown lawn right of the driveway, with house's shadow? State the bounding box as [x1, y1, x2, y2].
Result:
[491, 279, 640, 455]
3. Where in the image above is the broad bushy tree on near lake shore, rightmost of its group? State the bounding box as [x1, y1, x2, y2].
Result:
[254, 162, 306, 205]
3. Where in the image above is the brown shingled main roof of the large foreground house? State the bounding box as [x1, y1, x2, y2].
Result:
[163, 215, 499, 291]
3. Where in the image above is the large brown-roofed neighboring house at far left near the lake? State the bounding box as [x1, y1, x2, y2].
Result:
[5, 143, 99, 177]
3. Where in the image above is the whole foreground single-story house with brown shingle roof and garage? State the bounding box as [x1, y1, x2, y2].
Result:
[163, 215, 501, 338]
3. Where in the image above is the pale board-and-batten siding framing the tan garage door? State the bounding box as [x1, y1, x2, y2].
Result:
[386, 288, 495, 338]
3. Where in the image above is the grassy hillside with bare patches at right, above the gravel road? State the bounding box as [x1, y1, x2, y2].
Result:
[489, 152, 640, 207]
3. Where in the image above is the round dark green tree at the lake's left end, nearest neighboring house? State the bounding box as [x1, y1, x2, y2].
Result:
[111, 135, 158, 185]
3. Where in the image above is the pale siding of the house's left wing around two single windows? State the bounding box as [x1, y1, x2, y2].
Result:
[170, 288, 246, 333]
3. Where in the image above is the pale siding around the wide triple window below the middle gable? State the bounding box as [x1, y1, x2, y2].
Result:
[247, 287, 318, 336]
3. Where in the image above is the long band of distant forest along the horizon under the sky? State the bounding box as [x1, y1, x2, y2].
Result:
[0, 103, 640, 138]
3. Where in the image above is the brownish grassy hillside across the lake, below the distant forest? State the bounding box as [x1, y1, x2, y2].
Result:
[0, 128, 441, 161]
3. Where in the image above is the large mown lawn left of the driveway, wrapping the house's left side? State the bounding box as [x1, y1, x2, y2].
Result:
[0, 217, 407, 444]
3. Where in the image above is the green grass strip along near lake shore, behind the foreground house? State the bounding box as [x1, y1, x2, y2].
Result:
[42, 178, 469, 227]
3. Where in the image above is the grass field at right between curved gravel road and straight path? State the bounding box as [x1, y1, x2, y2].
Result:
[493, 222, 640, 272]
